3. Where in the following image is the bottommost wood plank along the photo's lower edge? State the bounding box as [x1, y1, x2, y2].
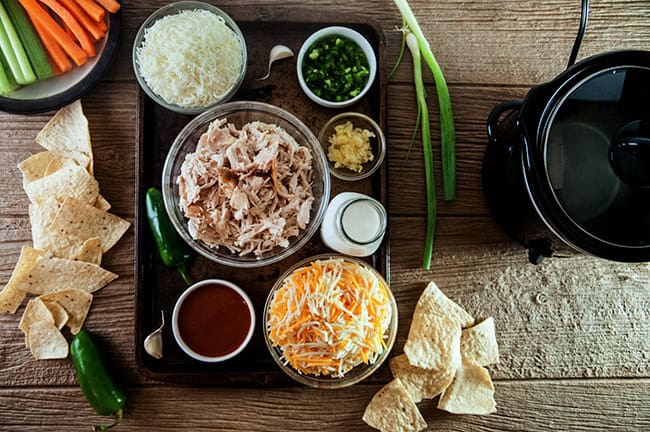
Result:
[0, 380, 650, 432]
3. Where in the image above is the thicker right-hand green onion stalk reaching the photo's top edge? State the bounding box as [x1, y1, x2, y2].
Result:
[394, 0, 456, 201]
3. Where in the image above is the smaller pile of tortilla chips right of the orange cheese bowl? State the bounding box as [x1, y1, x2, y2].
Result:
[363, 282, 499, 432]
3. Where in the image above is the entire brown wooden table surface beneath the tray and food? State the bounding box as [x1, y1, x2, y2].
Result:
[0, 0, 650, 431]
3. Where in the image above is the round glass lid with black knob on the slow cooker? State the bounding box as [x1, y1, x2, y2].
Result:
[542, 66, 650, 248]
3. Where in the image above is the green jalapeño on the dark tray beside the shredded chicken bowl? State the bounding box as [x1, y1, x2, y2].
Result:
[145, 187, 192, 285]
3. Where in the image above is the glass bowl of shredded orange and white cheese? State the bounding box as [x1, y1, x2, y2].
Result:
[262, 254, 397, 388]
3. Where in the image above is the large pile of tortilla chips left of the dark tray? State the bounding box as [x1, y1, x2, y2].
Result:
[0, 101, 131, 359]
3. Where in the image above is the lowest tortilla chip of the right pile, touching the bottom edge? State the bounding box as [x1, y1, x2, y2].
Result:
[363, 378, 427, 432]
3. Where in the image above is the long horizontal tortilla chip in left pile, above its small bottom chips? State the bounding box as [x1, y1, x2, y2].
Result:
[19, 256, 117, 296]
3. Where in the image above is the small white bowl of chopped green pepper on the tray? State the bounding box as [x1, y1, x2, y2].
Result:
[296, 26, 377, 108]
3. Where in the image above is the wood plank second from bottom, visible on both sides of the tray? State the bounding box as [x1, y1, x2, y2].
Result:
[0, 217, 650, 386]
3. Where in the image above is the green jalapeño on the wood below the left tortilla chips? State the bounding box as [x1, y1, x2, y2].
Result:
[70, 330, 126, 431]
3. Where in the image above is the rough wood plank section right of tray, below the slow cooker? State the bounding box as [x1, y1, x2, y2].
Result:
[390, 218, 650, 378]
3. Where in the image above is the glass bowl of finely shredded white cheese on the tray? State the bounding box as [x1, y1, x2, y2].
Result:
[133, 1, 247, 114]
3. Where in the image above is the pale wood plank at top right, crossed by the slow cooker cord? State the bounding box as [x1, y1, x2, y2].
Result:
[389, 0, 650, 85]
